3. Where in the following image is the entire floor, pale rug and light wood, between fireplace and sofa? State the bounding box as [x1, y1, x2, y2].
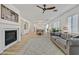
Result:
[2, 34, 64, 55]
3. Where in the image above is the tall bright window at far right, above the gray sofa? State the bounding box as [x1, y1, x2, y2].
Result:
[68, 15, 78, 33]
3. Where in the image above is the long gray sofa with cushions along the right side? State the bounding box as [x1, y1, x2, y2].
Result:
[50, 32, 79, 55]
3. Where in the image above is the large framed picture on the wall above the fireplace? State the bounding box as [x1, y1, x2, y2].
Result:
[1, 5, 18, 22]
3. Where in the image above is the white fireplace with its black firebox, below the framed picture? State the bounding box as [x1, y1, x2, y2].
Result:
[0, 23, 21, 53]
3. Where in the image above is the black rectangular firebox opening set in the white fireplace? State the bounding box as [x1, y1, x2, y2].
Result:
[5, 30, 17, 46]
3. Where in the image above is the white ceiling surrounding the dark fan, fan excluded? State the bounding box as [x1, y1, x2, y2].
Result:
[13, 4, 75, 23]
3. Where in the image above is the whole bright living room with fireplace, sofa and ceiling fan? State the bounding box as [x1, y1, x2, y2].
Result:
[0, 4, 79, 55]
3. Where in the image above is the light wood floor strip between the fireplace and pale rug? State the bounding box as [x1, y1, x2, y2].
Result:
[2, 33, 33, 55]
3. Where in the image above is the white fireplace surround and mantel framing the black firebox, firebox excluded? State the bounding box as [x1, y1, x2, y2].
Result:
[0, 23, 21, 53]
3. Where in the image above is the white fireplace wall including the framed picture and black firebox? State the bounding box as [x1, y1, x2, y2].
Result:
[0, 4, 21, 53]
